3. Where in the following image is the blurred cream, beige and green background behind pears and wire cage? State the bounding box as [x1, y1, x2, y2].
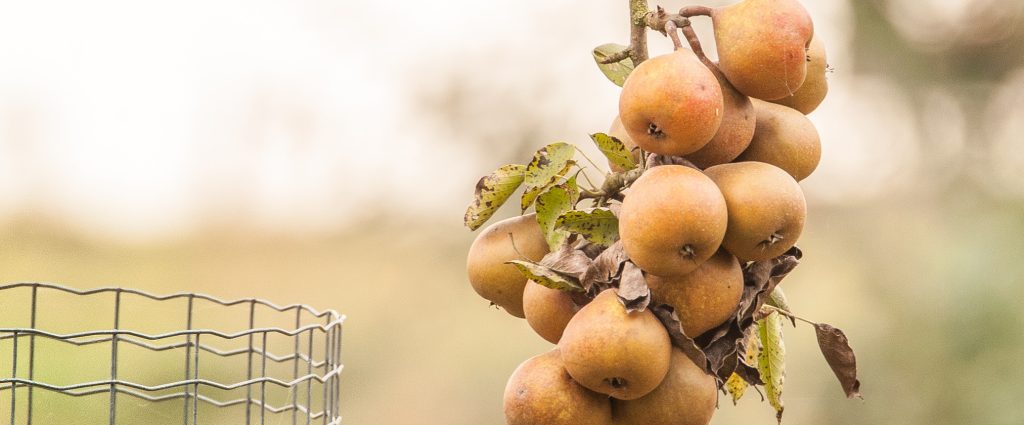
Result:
[0, 0, 1024, 424]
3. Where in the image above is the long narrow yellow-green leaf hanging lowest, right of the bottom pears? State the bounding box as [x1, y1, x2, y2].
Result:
[758, 311, 785, 423]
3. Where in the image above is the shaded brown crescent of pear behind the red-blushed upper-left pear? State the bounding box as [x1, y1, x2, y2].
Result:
[686, 67, 756, 169]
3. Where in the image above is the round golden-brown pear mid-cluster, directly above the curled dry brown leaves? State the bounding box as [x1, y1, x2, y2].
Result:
[618, 165, 729, 277]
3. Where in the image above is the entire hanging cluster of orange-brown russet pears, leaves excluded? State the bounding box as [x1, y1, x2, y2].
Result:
[467, 0, 827, 424]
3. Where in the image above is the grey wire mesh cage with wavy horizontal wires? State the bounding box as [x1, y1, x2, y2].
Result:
[0, 283, 345, 425]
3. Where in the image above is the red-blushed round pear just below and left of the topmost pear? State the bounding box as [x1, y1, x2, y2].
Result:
[618, 49, 724, 156]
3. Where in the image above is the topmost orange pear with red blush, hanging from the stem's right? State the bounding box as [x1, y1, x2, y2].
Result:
[711, 0, 814, 100]
